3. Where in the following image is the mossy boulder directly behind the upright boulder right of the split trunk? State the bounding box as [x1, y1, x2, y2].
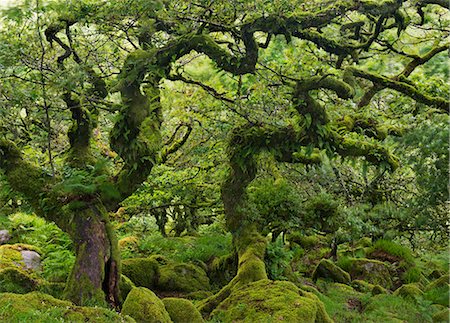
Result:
[122, 258, 159, 289]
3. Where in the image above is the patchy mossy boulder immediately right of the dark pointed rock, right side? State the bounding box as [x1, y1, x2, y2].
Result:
[343, 258, 393, 289]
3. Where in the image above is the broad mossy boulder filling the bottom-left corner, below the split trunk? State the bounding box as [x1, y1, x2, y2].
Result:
[0, 292, 134, 323]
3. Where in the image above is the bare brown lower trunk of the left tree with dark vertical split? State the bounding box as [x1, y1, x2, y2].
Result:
[64, 206, 120, 307]
